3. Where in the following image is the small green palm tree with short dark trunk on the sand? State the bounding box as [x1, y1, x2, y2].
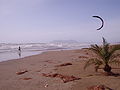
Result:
[84, 37, 120, 72]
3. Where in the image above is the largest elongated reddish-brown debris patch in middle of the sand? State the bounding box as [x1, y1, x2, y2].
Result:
[42, 73, 81, 83]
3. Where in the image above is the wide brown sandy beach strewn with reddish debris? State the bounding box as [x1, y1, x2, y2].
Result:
[0, 49, 120, 90]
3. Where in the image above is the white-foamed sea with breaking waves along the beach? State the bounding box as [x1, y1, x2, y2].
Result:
[0, 42, 90, 62]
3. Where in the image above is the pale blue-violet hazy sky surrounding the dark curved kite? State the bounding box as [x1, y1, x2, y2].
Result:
[0, 0, 120, 43]
